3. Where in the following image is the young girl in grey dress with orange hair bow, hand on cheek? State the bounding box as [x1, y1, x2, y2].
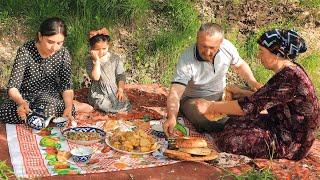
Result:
[87, 28, 130, 113]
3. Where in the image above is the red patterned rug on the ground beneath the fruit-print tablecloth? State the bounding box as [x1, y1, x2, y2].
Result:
[0, 85, 320, 179]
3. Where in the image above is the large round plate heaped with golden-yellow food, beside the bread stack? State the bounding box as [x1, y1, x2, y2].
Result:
[106, 129, 160, 154]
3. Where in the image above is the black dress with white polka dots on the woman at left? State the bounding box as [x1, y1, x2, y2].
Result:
[0, 41, 74, 123]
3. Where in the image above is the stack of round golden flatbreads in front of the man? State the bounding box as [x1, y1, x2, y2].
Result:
[164, 137, 218, 161]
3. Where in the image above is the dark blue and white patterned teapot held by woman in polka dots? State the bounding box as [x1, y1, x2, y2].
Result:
[26, 105, 54, 130]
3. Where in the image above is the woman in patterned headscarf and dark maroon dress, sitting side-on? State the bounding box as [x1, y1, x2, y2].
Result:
[196, 29, 320, 160]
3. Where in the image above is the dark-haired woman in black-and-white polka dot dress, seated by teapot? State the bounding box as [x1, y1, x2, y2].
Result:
[0, 17, 75, 124]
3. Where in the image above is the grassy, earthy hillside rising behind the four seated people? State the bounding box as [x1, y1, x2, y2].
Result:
[0, 0, 320, 91]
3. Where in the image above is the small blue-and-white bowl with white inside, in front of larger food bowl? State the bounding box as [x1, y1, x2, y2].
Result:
[71, 147, 93, 163]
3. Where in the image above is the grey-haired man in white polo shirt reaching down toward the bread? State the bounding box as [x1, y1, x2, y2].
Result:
[163, 23, 261, 136]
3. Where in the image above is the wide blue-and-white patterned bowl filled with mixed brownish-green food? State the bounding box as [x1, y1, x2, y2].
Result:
[62, 127, 106, 145]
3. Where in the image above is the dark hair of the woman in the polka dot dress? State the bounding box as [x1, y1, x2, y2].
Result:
[39, 17, 67, 37]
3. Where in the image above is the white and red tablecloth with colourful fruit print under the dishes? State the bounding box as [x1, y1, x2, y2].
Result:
[6, 124, 178, 178]
